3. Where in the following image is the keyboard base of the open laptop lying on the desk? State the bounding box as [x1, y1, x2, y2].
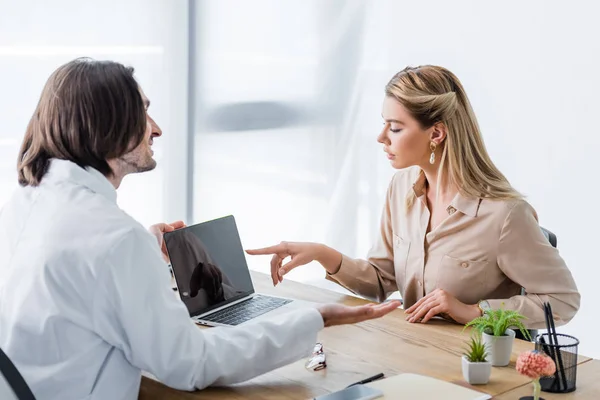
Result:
[200, 296, 292, 325]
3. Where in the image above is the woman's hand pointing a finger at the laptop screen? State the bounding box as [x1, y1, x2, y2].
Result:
[246, 242, 341, 286]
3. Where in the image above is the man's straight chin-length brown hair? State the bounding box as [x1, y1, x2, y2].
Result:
[17, 58, 146, 186]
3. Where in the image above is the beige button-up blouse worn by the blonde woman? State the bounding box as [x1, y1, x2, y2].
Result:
[327, 168, 580, 329]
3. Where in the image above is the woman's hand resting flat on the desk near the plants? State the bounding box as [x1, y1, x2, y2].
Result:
[405, 289, 481, 324]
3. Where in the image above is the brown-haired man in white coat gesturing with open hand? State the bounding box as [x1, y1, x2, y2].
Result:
[0, 59, 399, 400]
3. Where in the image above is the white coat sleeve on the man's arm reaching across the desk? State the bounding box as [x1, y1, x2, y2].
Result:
[93, 230, 323, 390]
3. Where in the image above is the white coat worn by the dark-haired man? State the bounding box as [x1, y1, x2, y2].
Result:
[0, 160, 323, 400]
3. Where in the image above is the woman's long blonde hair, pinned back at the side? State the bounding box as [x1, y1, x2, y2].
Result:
[385, 65, 522, 207]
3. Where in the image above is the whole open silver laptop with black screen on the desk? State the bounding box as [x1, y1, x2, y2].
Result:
[164, 215, 310, 326]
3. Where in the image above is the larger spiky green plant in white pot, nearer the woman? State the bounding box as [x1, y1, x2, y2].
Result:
[465, 308, 531, 367]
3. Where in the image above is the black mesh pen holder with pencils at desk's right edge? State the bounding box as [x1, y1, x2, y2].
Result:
[535, 333, 579, 393]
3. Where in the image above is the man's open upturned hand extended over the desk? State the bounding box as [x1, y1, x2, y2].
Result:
[317, 300, 402, 326]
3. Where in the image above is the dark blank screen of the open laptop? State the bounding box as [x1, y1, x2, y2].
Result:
[164, 216, 254, 317]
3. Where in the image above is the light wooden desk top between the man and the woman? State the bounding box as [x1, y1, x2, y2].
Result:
[139, 272, 590, 400]
